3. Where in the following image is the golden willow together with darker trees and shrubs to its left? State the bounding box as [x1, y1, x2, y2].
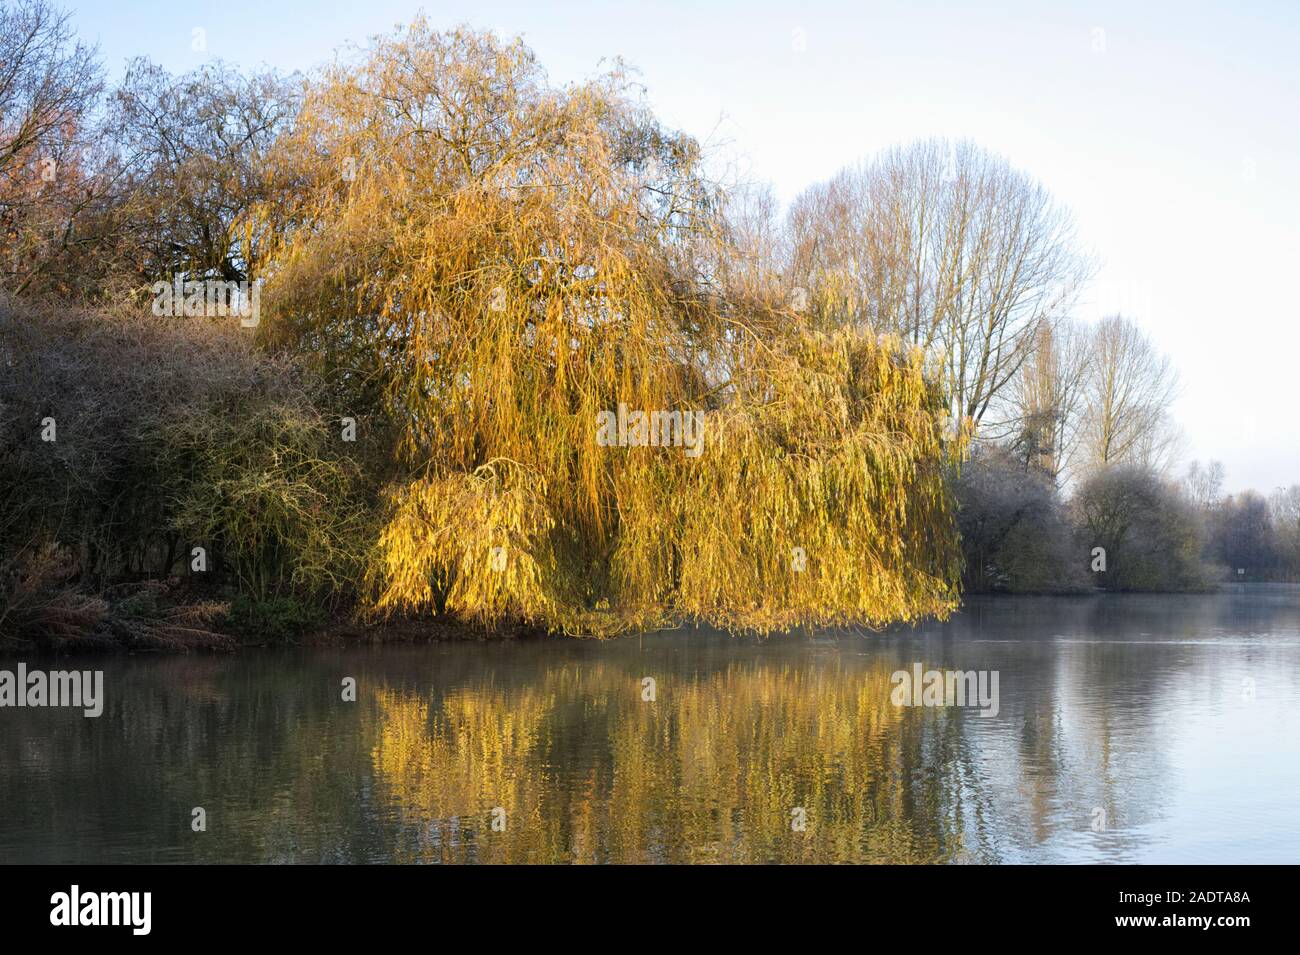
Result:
[0, 0, 965, 647]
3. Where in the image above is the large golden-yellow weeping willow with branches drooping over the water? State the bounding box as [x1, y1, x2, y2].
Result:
[244, 21, 959, 634]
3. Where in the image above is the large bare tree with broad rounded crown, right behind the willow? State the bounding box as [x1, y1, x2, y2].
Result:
[789, 139, 1092, 428]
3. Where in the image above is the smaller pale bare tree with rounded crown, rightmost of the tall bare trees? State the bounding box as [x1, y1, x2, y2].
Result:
[1083, 314, 1182, 472]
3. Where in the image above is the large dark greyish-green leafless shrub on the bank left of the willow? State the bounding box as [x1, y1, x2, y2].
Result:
[0, 303, 364, 608]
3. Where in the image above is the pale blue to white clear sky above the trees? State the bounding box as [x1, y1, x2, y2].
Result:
[64, 0, 1300, 491]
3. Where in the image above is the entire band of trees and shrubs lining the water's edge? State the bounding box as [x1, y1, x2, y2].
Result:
[0, 0, 1300, 648]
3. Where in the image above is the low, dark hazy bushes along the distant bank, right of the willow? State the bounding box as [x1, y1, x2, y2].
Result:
[956, 444, 1300, 594]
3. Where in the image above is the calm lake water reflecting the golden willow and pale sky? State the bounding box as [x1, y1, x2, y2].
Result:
[0, 586, 1300, 863]
